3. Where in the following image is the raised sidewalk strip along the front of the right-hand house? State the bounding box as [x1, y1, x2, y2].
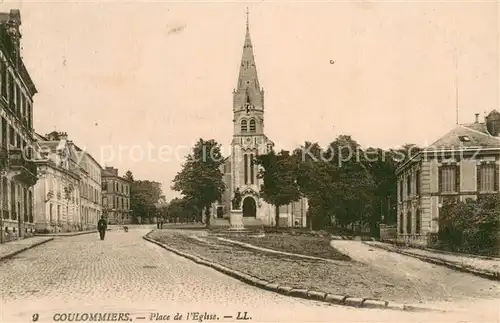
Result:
[364, 241, 500, 280]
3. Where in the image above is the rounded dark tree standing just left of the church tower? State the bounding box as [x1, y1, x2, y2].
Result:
[172, 139, 225, 226]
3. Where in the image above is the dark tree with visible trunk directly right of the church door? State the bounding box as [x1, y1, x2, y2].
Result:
[256, 150, 301, 231]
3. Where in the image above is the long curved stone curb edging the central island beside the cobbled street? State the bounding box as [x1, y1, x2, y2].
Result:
[142, 233, 444, 312]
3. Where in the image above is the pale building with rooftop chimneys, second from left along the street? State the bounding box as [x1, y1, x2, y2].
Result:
[34, 131, 82, 233]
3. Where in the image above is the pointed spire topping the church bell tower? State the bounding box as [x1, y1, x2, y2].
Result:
[236, 8, 260, 92]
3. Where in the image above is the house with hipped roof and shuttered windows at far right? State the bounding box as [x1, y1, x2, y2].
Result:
[396, 110, 500, 245]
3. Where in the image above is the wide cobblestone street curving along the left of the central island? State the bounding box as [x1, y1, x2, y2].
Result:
[0, 228, 495, 322]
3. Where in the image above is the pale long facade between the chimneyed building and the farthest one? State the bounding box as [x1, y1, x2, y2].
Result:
[71, 145, 102, 230]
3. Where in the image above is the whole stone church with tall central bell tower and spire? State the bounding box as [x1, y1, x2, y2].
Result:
[212, 11, 307, 227]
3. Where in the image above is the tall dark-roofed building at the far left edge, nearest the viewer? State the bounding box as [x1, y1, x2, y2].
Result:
[0, 10, 37, 242]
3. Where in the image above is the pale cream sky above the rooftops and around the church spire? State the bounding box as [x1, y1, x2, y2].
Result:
[0, 1, 500, 199]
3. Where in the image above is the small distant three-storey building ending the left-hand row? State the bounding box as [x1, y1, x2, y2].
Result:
[101, 167, 132, 224]
